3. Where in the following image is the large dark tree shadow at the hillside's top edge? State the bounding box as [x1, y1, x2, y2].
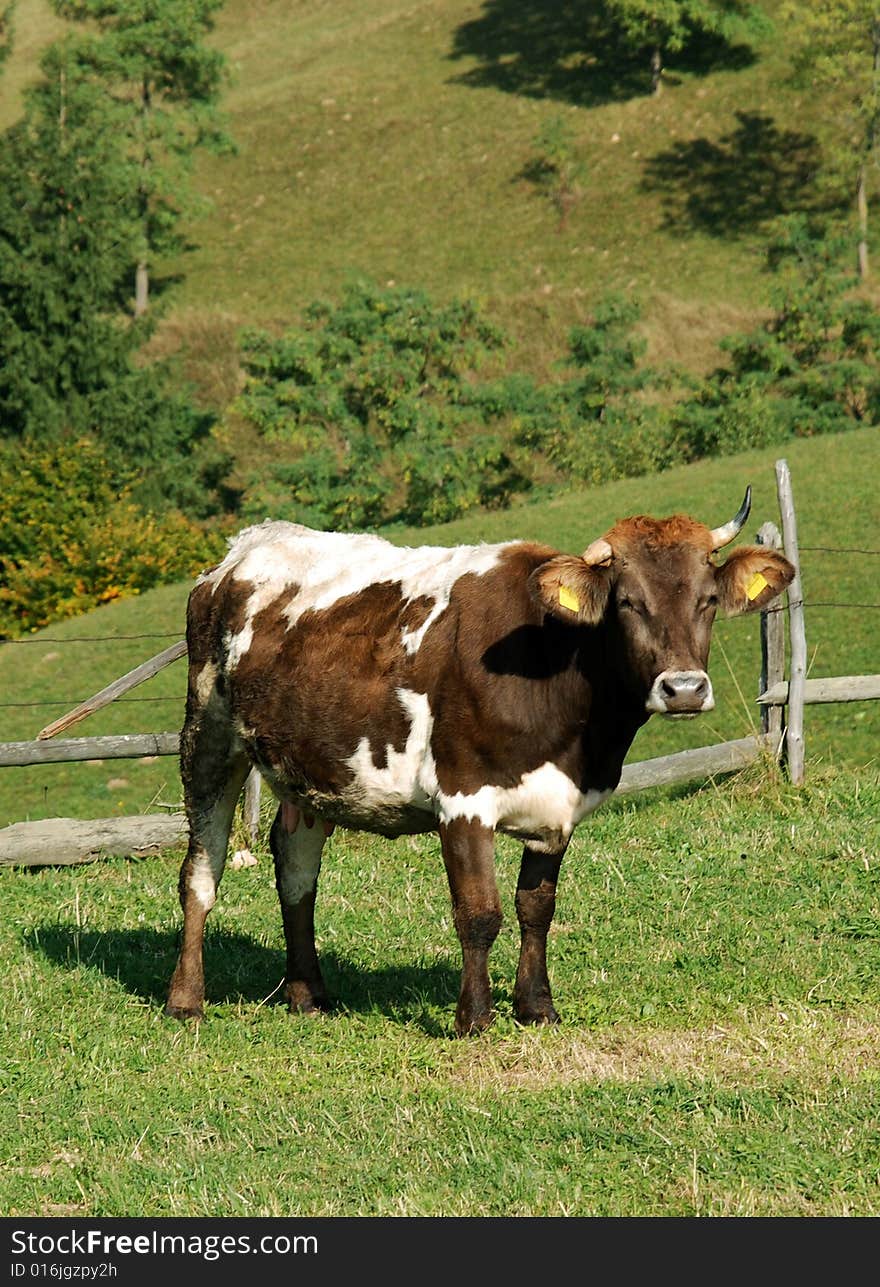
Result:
[449, 0, 755, 107]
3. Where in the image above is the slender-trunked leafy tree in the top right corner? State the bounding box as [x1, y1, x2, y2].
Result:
[784, 0, 880, 278]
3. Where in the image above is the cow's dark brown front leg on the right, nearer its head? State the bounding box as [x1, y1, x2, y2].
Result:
[513, 844, 562, 1023]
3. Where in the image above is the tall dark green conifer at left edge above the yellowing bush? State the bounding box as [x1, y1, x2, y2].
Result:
[0, 42, 142, 438]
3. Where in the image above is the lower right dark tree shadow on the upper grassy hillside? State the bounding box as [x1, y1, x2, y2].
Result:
[642, 111, 827, 237]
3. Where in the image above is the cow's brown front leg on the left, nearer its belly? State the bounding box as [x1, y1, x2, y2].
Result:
[440, 817, 502, 1037]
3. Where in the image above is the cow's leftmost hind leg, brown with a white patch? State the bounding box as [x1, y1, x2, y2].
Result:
[165, 712, 250, 1019]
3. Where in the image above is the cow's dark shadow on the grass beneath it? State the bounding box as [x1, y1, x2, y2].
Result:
[24, 921, 459, 1036]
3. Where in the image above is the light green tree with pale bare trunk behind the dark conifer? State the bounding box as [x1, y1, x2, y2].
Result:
[51, 0, 232, 317]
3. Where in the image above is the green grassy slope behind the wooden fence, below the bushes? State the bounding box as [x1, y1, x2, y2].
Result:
[0, 429, 880, 825]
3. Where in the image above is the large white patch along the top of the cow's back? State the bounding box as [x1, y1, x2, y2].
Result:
[209, 521, 520, 668]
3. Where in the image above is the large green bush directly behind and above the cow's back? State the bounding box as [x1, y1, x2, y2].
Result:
[234, 282, 529, 530]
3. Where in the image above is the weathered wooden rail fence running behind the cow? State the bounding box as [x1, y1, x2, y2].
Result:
[0, 461, 880, 866]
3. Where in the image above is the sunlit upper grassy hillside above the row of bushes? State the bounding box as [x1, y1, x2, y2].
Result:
[0, 0, 869, 405]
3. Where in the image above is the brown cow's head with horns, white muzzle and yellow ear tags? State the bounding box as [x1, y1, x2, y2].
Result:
[530, 488, 795, 716]
